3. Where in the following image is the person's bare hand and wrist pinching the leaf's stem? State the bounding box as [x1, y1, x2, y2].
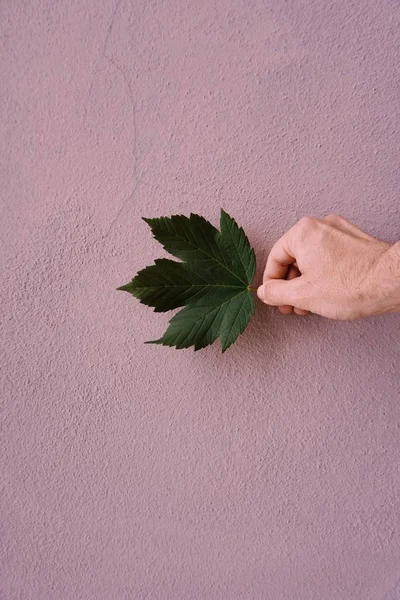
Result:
[257, 215, 400, 320]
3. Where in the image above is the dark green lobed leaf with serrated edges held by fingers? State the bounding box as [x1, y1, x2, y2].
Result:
[118, 210, 256, 352]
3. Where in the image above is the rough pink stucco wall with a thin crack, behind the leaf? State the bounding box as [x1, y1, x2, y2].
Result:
[0, 0, 400, 600]
